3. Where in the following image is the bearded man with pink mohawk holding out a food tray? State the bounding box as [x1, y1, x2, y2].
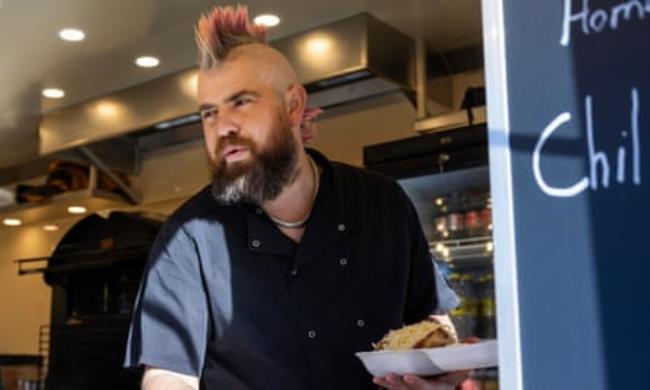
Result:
[125, 3, 466, 390]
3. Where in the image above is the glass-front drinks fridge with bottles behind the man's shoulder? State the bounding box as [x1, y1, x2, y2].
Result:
[364, 125, 498, 389]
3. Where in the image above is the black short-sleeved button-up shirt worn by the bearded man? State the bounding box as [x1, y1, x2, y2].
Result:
[125, 151, 457, 390]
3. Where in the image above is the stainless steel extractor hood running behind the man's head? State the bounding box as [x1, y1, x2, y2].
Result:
[39, 13, 414, 155]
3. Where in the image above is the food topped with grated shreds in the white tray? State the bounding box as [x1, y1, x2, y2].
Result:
[373, 318, 458, 351]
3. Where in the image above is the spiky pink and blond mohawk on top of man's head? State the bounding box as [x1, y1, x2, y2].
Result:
[194, 5, 266, 70]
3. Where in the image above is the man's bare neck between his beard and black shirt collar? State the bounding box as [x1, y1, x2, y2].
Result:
[262, 152, 318, 232]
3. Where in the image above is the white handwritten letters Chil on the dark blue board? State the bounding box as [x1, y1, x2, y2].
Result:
[532, 88, 641, 198]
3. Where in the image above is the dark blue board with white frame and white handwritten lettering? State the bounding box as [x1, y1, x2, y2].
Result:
[483, 0, 650, 389]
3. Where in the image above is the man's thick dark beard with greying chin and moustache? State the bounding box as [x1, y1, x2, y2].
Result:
[212, 122, 298, 205]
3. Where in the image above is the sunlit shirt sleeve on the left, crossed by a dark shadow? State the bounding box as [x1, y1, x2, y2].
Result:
[124, 220, 208, 377]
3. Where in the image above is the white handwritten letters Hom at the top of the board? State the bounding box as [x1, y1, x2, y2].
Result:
[560, 0, 650, 46]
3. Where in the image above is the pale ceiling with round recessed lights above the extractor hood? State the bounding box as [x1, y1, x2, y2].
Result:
[0, 0, 481, 166]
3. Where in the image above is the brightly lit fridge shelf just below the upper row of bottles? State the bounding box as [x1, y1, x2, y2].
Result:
[429, 236, 494, 264]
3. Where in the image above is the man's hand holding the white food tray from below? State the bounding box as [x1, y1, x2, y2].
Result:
[372, 371, 470, 390]
